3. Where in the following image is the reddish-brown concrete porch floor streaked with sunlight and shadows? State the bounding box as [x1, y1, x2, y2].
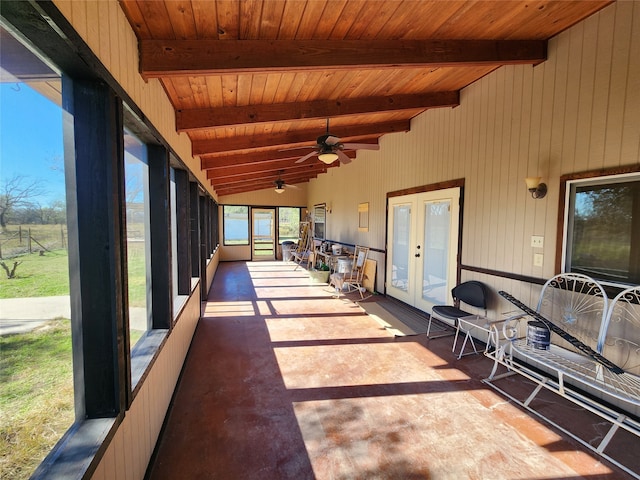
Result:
[147, 262, 640, 480]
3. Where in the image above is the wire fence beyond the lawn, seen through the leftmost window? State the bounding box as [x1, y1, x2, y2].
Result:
[0, 225, 68, 259]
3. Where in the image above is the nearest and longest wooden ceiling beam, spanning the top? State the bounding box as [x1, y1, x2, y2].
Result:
[139, 39, 547, 78]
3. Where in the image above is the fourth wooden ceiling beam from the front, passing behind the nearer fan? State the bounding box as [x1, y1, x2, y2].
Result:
[200, 151, 364, 171]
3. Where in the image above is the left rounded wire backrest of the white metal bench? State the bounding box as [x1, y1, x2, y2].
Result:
[537, 273, 608, 353]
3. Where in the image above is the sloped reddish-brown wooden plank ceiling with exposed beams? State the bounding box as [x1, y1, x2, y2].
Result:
[120, 0, 611, 196]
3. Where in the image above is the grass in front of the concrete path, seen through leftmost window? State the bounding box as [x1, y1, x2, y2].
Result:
[0, 319, 74, 480]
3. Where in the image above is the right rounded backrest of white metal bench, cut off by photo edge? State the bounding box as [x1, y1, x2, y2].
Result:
[601, 285, 640, 375]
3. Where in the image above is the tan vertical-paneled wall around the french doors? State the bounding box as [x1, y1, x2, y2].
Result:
[309, 0, 640, 303]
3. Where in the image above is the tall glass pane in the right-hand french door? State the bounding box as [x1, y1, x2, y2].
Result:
[422, 200, 451, 304]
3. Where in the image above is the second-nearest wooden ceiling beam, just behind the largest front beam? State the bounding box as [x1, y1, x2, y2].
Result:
[176, 92, 460, 132]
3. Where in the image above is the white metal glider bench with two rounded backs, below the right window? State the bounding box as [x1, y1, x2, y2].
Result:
[484, 274, 640, 479]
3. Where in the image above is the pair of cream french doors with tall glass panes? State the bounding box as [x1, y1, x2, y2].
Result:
[386, 187, 460, 312]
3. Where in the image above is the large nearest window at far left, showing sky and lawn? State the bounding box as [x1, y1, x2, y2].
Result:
[0, 21, 75, 479]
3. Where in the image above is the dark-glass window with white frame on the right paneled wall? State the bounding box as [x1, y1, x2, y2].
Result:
[564, 174, 640, 284]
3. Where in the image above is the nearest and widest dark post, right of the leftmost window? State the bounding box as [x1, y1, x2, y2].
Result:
[63, 77, 131, 419]
